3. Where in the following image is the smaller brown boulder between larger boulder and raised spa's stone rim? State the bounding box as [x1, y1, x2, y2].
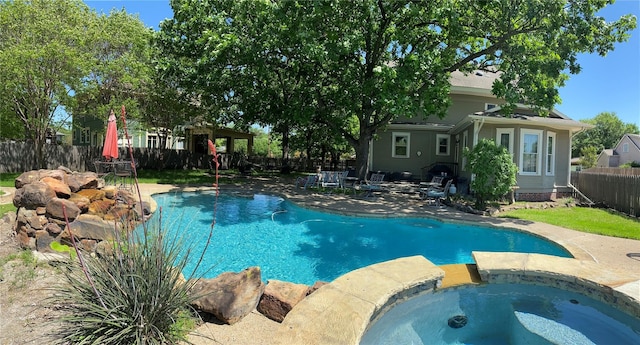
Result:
[258, 280, 309, 322]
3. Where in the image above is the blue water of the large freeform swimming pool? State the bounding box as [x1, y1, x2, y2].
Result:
[151, 192, 571, 285]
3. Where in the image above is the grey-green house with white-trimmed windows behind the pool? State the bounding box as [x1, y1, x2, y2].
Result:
[369, 71, 592, 201]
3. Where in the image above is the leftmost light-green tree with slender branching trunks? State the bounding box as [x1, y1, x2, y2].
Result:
[0, 0, 95, 168]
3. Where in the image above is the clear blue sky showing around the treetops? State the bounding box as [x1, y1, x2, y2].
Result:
[85, 0, 640, 127]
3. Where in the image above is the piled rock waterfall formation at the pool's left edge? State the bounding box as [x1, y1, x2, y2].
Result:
[13, 167, 150, 252]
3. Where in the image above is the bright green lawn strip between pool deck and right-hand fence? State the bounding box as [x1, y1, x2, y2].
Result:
[499, 207, 640, 240]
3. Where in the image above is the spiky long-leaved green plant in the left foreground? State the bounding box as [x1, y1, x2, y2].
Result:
[53, 227, 200, 345]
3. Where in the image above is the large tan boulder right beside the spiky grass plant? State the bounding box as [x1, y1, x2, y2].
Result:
[191, 267, 265, 325]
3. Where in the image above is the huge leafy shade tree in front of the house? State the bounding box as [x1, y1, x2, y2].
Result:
[161, 0, 636, 177]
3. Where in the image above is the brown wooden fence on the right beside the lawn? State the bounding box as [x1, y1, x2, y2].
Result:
[571, 168, 640, 217]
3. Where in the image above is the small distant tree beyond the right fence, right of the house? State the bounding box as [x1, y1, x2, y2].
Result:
[571, 112, 640, 157]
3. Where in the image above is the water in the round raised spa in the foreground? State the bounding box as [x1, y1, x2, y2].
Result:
[360, 284, 640, 345]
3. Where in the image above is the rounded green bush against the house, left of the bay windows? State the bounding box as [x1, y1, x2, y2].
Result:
[464, 139, 518, 209]
